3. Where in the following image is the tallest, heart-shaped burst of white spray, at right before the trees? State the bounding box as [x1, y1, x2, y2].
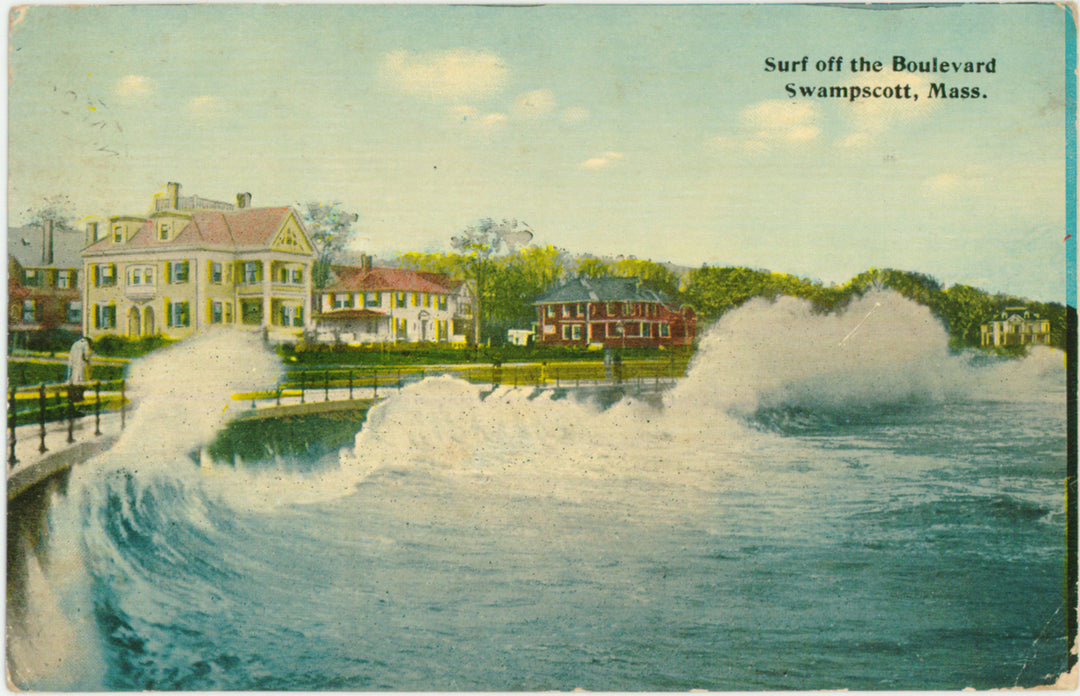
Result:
[666, 291, 1063, 418]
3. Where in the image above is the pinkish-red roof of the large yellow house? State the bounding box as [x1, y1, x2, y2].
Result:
[83, 206, 291, 254]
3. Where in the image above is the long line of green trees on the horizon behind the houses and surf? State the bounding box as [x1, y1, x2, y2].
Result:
[395, 220, 1066, 349]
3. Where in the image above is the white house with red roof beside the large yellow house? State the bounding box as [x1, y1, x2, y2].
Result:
[315, 255, 472, 344]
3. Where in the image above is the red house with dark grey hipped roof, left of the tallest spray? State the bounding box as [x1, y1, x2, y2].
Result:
[532, 278, 698, 348]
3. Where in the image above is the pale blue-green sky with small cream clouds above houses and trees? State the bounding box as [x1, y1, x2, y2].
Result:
[8, 3, 1068, 302]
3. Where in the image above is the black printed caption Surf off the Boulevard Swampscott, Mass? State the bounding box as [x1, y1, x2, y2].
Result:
[764, 55, 997, 102]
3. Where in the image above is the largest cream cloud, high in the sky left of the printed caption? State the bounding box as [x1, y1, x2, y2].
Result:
[381, 49, 510, 99]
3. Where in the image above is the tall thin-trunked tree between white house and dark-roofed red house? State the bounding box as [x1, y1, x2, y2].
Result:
[450, 217, 532, 345]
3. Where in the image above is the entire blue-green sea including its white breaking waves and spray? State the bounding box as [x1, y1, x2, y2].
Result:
[8, 293, 1067, 691]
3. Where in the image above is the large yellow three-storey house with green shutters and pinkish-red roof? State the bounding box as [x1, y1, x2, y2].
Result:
[82, 184, 314, 340]
